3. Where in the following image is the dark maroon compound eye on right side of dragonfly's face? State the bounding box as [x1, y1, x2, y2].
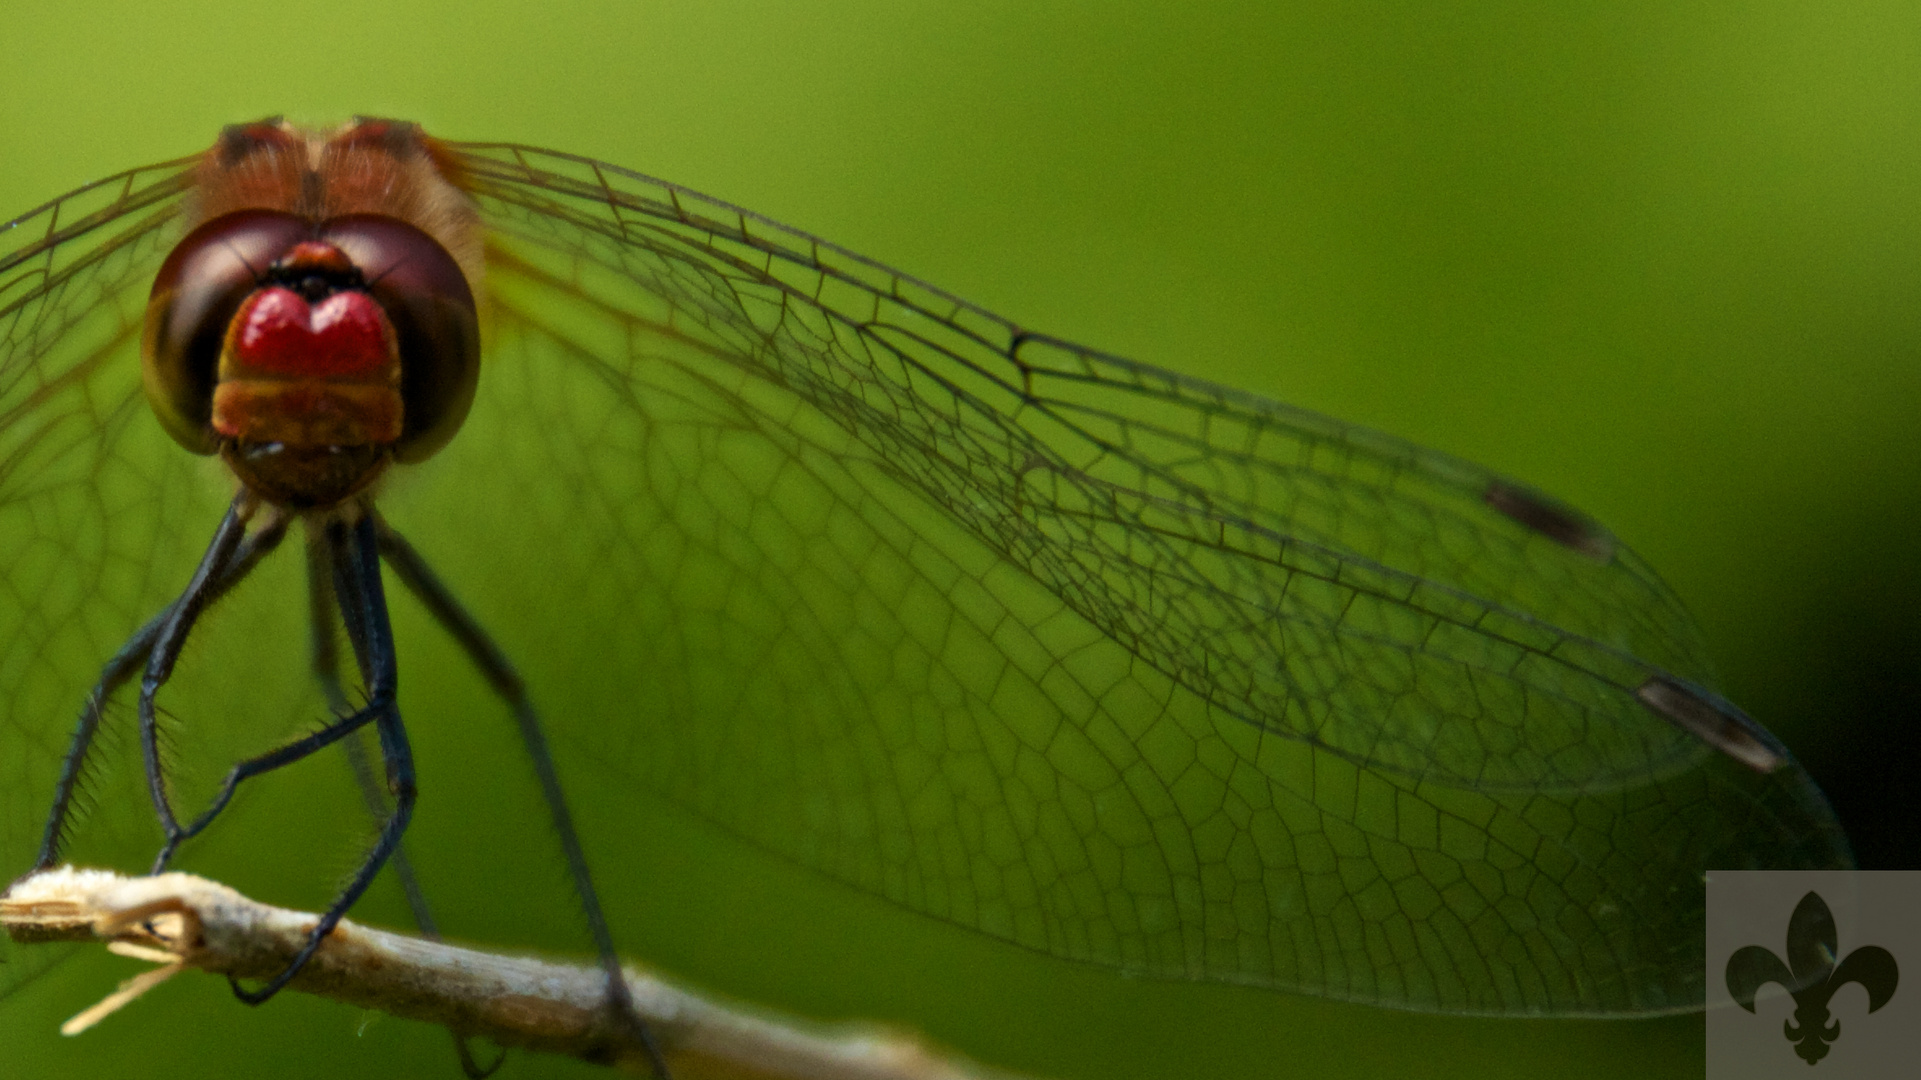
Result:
[319, 213, 480, 461]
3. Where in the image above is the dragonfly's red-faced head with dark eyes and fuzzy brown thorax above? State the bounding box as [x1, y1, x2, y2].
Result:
[142, 121, 480, 509]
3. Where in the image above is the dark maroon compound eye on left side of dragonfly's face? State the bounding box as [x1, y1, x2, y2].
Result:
[140, 209, 313, 454]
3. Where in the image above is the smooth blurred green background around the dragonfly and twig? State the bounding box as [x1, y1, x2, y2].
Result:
[0, 0, 1921, 1078]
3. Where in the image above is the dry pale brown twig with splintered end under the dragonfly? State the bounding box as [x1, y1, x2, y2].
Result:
[0, 867, 1021, 1080]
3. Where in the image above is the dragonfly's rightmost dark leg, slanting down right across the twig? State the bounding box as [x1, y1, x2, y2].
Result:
[373, 515, 669, 1080]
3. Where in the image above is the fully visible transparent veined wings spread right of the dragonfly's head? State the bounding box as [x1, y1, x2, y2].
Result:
[416, 144, 1848, 1015]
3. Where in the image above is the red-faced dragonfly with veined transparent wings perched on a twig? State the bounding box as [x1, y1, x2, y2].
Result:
[0, 119, 1852, 1053]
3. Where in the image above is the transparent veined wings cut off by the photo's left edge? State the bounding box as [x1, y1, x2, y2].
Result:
[0, 153, 219, 994]
